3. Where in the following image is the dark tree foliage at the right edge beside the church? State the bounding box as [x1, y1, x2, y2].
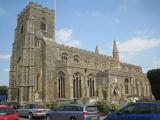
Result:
[147, 69, 160, 100]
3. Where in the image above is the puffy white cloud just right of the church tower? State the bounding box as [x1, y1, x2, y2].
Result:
[56, 28, 80, 47]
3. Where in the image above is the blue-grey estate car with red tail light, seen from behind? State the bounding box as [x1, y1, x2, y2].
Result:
[46, 104, 99, 120]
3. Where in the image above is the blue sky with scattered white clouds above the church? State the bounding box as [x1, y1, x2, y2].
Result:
[0, 0, 160, 85]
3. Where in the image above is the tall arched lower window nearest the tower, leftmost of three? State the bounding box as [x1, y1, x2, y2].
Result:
[58, 72, 65, 98]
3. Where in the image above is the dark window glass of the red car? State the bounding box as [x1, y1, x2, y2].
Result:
[0, 108, 16, 116]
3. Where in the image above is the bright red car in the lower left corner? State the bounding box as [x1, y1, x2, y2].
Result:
[0, 105, 19, 120]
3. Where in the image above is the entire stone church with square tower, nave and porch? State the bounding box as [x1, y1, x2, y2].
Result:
[9, 2, 152, 104]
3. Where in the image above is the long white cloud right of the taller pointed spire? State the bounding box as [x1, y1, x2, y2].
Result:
[118, 38, 160, 54]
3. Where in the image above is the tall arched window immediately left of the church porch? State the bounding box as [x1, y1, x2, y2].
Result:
[87, 74, 95, 97]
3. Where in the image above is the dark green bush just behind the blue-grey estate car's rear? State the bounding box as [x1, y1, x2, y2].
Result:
[96, 101, 109, 113]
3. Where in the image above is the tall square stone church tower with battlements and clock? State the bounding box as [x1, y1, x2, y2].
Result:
[9, 2, 55, 104]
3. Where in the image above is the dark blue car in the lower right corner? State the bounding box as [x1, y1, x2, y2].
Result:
[104, 102, 160, 120]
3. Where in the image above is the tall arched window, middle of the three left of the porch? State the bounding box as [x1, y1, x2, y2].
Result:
[73, 73, 82, 98]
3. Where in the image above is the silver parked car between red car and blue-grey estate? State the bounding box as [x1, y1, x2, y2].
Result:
[17, 104, 50, 119]
